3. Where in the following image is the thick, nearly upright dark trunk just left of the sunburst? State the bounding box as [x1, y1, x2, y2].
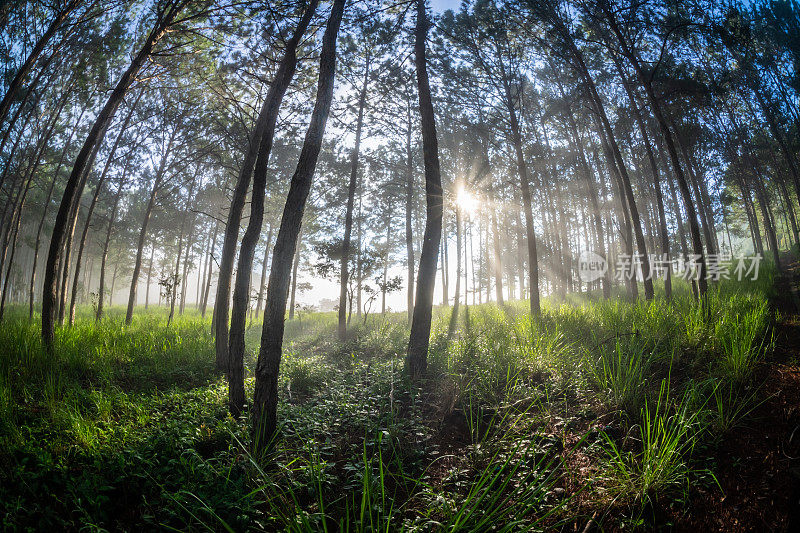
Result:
[406, 0, 444, 378]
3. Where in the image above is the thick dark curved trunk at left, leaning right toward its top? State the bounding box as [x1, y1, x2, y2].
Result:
[42, 0, 188, 351]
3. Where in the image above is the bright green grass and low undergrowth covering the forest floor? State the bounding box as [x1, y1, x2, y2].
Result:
[0, 269, 778, 531]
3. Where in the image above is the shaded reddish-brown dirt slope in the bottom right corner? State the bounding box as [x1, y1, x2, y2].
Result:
[676, 262, 800, 533]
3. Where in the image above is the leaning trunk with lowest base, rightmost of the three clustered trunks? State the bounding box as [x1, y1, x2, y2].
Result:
[252, 0, 345, 453]
